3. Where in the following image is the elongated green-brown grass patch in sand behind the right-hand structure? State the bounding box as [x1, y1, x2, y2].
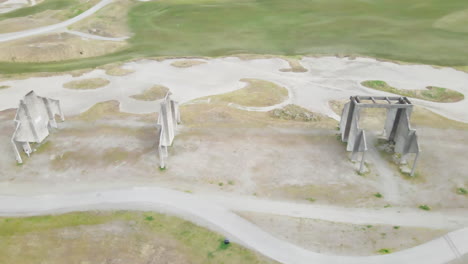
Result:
[361, 80, 465, 103]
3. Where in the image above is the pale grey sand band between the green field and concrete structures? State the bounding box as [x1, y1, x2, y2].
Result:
[0, 57, 468, 122]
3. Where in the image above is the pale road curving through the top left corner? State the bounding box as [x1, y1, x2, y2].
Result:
[0, 0, 113, 42]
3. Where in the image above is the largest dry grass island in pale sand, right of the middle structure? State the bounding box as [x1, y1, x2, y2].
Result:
[201, 79, 288, 107]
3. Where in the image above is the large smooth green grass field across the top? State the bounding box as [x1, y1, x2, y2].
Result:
[0, 0, 468, 73]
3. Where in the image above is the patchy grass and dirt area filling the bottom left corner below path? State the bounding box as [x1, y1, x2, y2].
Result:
[0, 211, 274, 264]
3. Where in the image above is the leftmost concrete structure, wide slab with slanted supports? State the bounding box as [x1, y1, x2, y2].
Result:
[11, 91, 64, 163]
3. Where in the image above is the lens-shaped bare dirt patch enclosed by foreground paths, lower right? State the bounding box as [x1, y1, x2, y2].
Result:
[239, 212, 449, 256]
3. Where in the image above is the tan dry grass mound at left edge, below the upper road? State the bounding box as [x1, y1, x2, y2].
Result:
[0, 33, 126, 62]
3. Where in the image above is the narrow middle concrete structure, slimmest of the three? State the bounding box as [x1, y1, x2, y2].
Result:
[157, 92, 180, 169]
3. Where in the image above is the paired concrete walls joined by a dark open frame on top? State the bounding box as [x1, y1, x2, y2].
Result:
[340, 96, 420, 176]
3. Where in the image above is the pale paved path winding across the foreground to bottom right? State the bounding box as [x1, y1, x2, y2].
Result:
[0, 188, 468, 264]
